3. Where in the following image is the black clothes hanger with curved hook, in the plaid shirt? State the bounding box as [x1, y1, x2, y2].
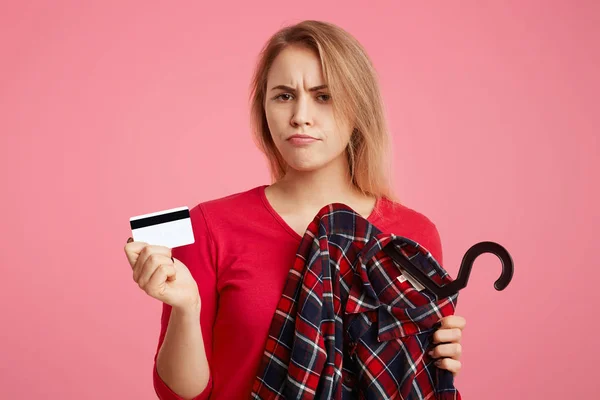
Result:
[383, 241, 514, 298]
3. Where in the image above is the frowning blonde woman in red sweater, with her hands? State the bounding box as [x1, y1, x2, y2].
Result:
[125, 21, 465, 399]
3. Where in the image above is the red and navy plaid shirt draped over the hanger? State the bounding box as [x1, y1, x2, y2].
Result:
[251, 204, 460, 400]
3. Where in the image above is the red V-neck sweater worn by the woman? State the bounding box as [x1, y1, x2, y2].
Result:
[154, 185, 443, 400]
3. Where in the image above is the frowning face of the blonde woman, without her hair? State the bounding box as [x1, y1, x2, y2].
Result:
[265, 46, 352, 171]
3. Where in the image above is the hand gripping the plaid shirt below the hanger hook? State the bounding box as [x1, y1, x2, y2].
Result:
[429, 315, 467, 376]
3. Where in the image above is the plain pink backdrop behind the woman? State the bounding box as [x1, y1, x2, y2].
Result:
[0, 0, 600, 400]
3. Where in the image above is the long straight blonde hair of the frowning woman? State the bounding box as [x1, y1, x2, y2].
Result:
[250, 20, 395, 199]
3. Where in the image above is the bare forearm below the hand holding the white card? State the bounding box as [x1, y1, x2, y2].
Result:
[156, 307, 209, 399]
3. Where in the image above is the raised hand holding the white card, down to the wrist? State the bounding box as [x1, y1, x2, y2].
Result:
[125, 238, 200, 310]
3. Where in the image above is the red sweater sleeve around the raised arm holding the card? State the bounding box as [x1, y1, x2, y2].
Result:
[153, 204, 217, 400]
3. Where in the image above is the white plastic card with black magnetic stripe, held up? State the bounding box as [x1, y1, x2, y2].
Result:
[129, 207, 194, 249]
